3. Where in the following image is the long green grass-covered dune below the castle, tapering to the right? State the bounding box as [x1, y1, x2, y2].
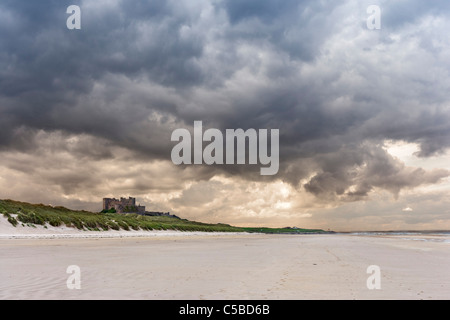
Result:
[0, 200, 323, 233]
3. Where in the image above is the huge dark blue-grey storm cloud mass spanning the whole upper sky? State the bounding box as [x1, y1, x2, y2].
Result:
[0, 0, 450, 201]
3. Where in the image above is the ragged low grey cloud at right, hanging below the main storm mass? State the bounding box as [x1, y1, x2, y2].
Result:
[304, 144, 450, 201]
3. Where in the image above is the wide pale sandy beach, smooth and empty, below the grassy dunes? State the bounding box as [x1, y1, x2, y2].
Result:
[0, 218, 450, 300]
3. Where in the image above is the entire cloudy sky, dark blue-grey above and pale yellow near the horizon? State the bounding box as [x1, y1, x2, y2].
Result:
[0, 0, 450, 231]
